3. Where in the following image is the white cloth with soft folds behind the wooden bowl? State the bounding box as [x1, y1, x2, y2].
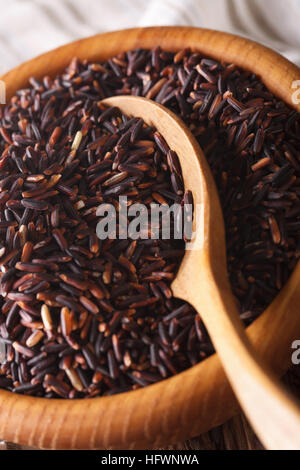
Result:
[0, 0, 300, 74]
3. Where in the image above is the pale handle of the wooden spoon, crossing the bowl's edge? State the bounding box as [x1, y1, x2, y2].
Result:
[193, 279, 300, 450]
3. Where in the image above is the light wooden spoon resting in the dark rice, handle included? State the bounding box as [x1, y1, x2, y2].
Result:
[103, 96, 300, 449]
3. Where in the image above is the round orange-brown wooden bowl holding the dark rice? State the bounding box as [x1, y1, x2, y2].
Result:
[0, 27, 300, 449]
